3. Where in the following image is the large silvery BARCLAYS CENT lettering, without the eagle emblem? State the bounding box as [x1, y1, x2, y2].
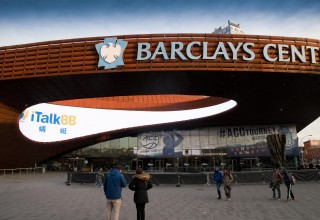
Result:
[137, 41, 320, 63]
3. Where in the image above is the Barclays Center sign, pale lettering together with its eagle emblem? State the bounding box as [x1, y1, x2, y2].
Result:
[96, 38, 320, 69]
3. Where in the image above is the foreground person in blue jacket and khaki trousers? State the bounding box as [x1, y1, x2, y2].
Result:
[103, 166, 127, 220]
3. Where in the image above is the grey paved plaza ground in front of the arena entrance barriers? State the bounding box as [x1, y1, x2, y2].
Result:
[0, 172, 320, 220]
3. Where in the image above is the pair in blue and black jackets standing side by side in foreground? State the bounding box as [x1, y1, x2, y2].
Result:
[103, 166, 152, 220]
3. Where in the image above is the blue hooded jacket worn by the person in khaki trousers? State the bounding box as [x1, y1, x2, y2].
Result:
[103, 169, 127, 200]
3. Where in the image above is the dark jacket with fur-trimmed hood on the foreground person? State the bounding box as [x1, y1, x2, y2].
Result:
[129, 173, 153, 203]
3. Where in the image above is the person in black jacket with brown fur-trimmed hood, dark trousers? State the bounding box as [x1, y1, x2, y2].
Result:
[129, 168, 152, 220]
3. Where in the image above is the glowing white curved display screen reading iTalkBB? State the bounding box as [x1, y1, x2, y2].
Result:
[19, 100, 236, 142]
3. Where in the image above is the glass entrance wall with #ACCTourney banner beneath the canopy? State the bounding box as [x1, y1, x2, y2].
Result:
[60, 125, 299, 172]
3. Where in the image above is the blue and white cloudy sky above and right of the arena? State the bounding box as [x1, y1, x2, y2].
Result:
[0, 0, 320, 140]
